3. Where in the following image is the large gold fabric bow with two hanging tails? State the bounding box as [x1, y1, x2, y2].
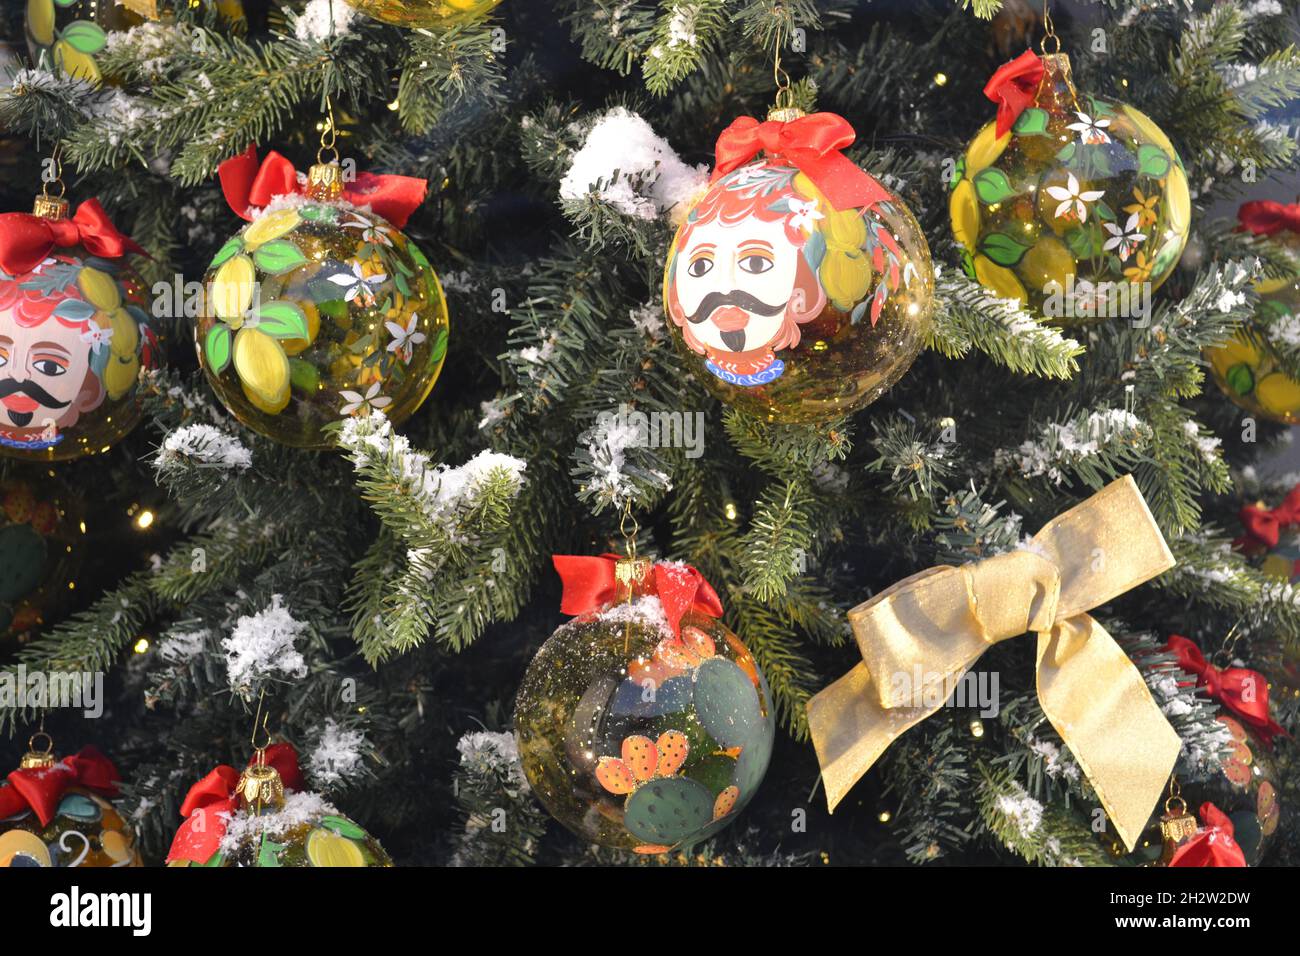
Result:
[807, 475, 1182, 849]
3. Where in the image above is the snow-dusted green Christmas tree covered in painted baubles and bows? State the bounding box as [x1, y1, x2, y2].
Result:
[0, 0, 1300, 866]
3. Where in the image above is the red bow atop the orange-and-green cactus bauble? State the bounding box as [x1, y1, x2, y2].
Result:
[551, 554, 723, 636]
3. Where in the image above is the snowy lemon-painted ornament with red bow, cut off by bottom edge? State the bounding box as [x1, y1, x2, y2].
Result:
[166, 744, 393, 868]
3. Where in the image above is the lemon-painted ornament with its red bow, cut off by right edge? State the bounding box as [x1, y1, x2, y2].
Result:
[1205, 200, 1300, 425]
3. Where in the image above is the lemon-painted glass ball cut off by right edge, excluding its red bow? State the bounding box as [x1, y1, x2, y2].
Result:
[1205, 278, 1300, 425]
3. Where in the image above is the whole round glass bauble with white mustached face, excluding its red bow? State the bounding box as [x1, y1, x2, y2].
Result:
[663, 157, 935, 423]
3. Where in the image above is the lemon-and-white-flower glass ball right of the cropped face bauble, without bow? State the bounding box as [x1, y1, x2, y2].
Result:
[195, 196, 449, 449]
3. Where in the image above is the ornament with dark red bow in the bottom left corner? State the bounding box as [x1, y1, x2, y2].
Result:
[0, 734, 140, 866]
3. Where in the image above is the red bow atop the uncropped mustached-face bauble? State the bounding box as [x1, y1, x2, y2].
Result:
[712, 113, 891, 209]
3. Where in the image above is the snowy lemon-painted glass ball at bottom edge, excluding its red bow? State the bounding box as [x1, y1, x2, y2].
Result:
[168, 792, 393, 866]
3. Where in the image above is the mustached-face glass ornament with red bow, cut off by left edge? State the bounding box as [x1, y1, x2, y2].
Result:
[0, 196, 159, 460]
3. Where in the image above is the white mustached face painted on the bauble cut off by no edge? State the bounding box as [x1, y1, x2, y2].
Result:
[673, 217, 802, 352]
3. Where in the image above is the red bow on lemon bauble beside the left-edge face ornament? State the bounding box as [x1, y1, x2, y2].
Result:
[217, 146, 429, 229]
